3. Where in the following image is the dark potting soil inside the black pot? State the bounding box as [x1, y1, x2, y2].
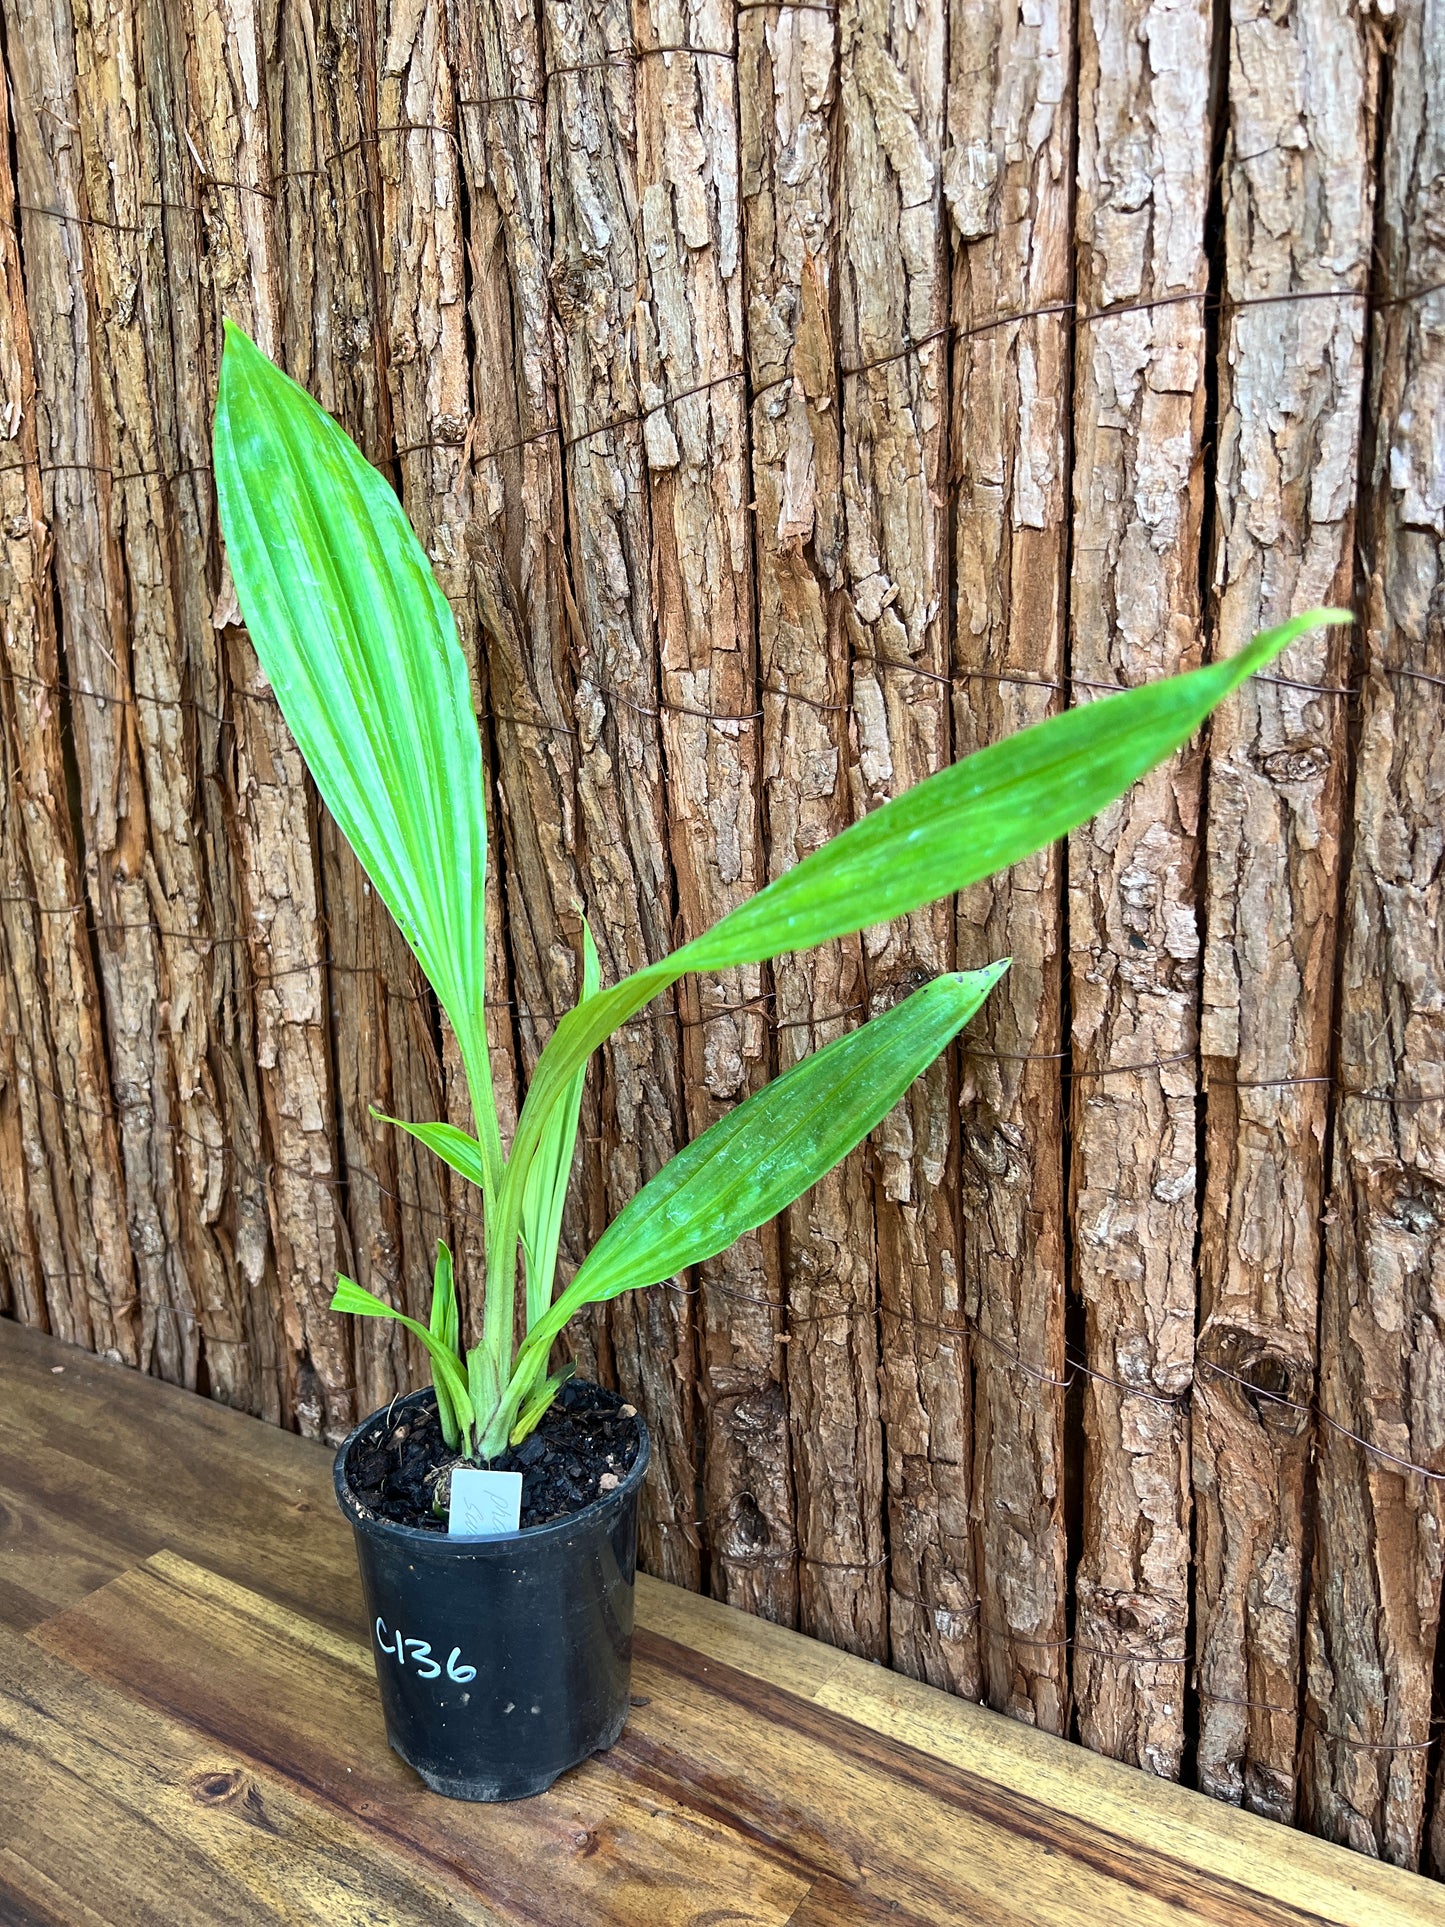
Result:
[347, 1380, 642, 1532]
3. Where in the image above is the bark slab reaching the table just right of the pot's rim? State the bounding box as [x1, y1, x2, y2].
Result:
[543, 0, 701, 1586]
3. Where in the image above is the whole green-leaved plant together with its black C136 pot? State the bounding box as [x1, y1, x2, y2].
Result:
[216, 324, 1349, 1800]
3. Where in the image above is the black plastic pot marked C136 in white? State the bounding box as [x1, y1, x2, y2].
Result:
[335, 1391, 649, 1800]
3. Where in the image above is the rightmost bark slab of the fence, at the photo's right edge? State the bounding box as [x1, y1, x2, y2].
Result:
[1304, 0, 1445, 1869]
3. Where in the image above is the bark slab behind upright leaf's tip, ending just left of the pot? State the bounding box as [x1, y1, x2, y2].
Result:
[187, 0, 356, 1438]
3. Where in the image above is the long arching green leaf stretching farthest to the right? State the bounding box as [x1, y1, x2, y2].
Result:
[503, 609, 1353, 1256]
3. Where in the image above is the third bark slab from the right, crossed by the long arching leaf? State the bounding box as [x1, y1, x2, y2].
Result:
[1069, 0, 1210, 1777]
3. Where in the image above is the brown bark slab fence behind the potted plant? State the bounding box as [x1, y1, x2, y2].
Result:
[0, 0, 1445, 1873]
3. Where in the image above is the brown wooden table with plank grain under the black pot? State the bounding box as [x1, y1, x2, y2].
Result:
[0, 1320, 1445, 1927]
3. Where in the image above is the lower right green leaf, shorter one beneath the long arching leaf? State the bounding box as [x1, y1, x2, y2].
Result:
[484, 960, 1008, 1451]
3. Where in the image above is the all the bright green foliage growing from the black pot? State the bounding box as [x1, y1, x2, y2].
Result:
[216, 326, 1349, 1459]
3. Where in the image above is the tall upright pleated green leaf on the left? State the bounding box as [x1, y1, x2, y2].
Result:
[216, 322, 503, 1204]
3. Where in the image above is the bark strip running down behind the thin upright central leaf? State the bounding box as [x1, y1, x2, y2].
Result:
[457, 4, 609, 1341]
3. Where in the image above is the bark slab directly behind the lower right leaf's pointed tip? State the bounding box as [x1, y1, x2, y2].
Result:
[944, 4, 1073, 1732]
